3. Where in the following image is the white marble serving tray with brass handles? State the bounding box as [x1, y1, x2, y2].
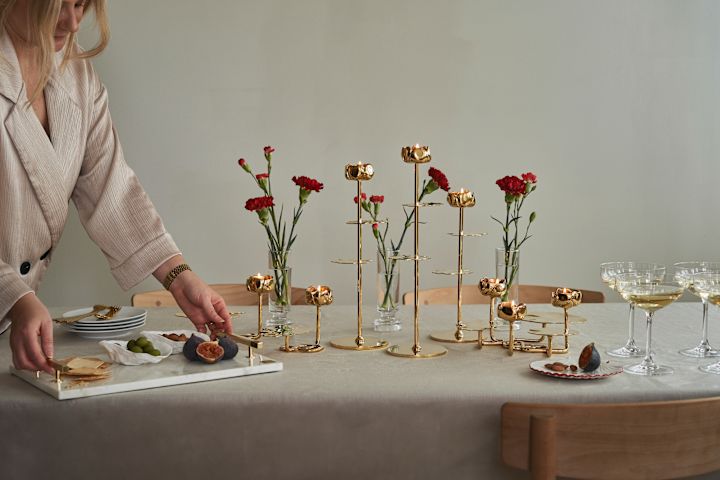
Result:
[10, 349, 283, 400]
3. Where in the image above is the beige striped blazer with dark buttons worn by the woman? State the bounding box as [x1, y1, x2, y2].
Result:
[0, 32, 179, 319]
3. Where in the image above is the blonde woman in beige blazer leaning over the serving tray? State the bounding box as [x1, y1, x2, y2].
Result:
[0, 0, 232, 372]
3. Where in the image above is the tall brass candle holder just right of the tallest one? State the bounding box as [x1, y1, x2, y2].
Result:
[430, 188, 486, 343]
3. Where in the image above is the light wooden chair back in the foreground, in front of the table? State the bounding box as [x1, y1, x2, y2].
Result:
[501, 397, 720, 480]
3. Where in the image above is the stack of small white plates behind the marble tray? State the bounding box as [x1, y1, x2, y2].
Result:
[63, 307, 147, 339]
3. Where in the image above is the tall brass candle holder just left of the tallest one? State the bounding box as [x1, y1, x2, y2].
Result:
[330, 162, 388, 350]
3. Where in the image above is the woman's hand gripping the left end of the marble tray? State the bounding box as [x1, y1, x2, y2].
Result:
[8, 293, 54, 375]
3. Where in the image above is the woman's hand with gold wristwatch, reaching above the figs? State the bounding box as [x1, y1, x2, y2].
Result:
[170, 270, 232, 336]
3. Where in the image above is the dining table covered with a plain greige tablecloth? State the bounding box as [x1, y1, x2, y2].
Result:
[0, 302, 720, 480]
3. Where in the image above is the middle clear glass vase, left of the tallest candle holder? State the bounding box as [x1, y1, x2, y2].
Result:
[373, 251, 402, 332]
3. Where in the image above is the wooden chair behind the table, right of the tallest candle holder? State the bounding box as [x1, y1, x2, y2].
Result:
[403, 285, 605, 305]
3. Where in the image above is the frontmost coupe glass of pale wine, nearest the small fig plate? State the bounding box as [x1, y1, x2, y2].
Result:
[615, 273, 684, 376]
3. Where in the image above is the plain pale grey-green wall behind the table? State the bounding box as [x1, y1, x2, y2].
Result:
[40, 0, 720, 305]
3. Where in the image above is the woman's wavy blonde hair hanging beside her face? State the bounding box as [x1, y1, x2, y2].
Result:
[0, 0, 110, 104]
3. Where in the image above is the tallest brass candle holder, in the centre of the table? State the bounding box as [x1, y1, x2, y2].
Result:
[387, 144, 447, 358]
